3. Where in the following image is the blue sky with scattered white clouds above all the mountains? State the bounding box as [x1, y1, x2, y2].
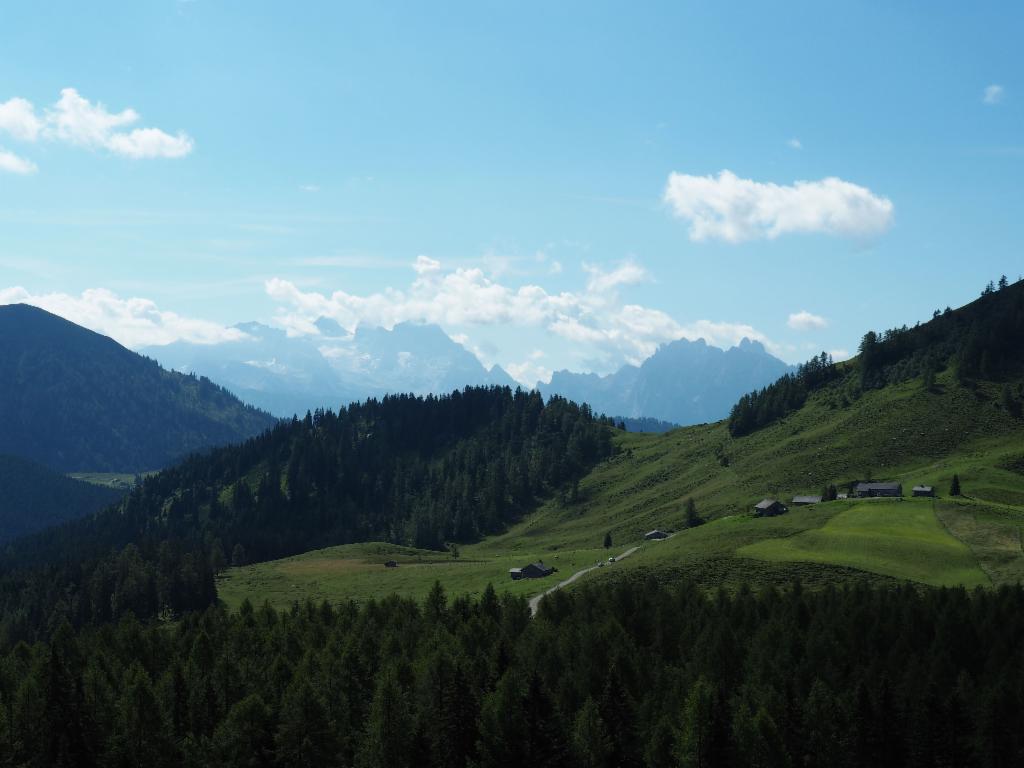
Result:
[0, 0, 1024, 381]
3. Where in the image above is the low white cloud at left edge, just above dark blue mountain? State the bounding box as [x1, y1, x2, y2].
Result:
[0, 287, 247, 349]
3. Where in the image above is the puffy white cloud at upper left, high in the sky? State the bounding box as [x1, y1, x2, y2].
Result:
[0, 88, 195, 168]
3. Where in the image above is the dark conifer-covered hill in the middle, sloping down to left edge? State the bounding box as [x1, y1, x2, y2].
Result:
[0, 387, 612, 640]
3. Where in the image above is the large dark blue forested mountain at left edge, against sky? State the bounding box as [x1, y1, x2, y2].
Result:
[0, 304, 273, 472]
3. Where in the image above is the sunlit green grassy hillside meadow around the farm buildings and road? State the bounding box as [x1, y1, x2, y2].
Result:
[219, 375, 1024, 606]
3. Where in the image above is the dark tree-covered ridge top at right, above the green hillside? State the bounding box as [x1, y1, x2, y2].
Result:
[728, 278, 1024, 437]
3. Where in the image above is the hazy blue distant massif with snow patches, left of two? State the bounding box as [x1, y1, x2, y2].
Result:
[143, 317, 517, 417]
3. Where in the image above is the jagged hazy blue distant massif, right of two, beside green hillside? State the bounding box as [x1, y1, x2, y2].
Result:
[537, 339, 795, 423]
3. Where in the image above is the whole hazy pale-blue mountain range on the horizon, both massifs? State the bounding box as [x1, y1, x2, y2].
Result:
[142, 317, 794, 431]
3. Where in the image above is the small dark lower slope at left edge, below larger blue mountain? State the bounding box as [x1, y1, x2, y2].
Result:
[0, 456, 122, 543]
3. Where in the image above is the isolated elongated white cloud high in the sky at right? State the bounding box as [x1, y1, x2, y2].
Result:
[665, 170, 893, 243]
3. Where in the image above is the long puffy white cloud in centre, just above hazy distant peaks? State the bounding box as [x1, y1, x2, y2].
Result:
[266, 256, 777, 366]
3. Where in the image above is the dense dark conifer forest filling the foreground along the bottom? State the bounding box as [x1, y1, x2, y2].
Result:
[0, 581, 1024, 768]
